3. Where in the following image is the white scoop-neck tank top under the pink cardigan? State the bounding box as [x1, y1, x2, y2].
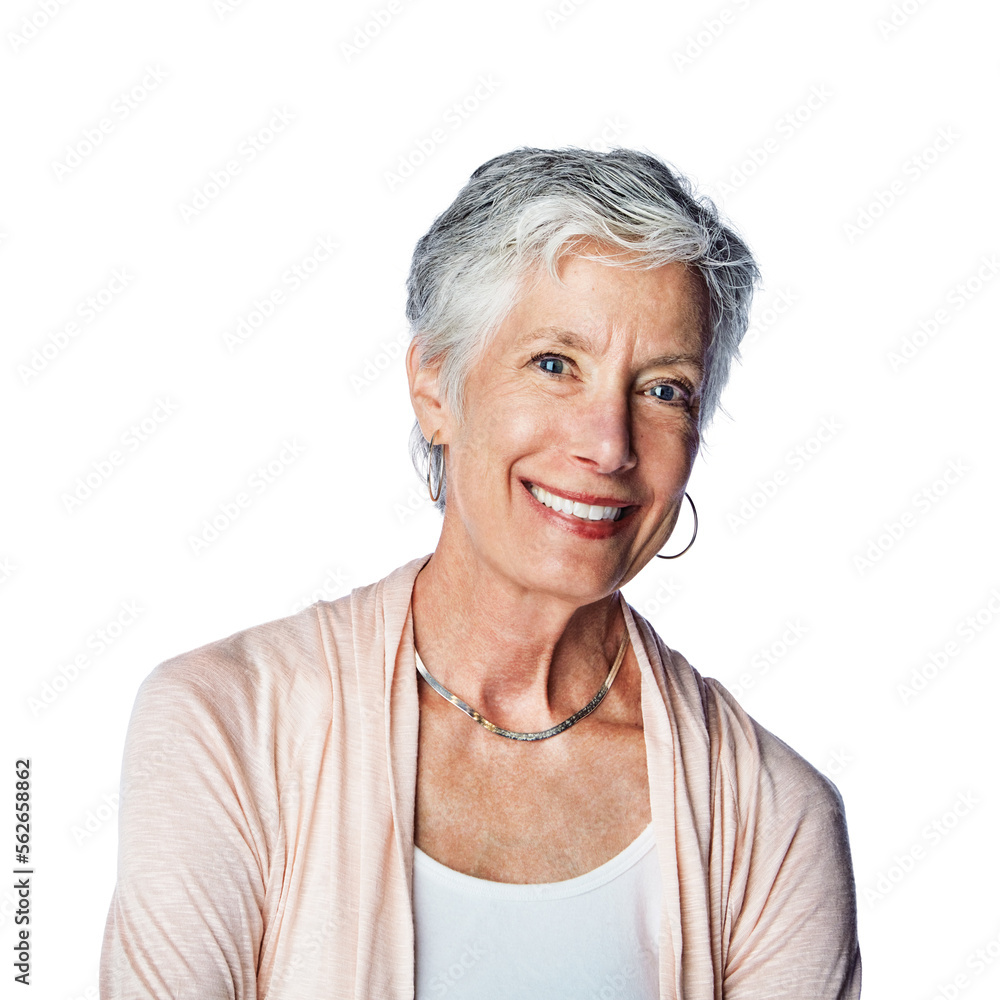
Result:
[413, 823, 660, 1000]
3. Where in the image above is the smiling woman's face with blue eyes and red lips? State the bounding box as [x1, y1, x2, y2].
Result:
[426, 247, 708, 604]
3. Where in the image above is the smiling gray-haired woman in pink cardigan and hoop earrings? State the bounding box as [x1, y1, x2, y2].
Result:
[101, 149, 860, 1000]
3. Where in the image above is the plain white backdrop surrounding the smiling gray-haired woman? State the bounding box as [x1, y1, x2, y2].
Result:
[0, 0, 1000, 1000]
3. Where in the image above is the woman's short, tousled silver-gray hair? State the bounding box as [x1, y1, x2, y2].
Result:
[406, 147, 760, 513]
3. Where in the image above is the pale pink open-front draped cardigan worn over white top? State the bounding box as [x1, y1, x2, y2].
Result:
[100, 556, 861, 1000]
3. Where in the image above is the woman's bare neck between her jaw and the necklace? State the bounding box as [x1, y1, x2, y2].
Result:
[413, 544, 625, 731]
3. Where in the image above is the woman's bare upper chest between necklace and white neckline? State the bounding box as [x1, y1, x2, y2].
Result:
[414, 692, 651, 883]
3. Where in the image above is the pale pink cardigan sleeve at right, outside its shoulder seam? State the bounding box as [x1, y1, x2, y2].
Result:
[701, 678, 860, 984]
